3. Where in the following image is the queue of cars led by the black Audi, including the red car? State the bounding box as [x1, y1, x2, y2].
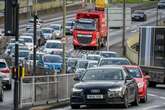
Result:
[67, 51, 150, 109]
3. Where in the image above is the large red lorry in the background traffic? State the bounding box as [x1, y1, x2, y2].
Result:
[73, 11, 108, 49]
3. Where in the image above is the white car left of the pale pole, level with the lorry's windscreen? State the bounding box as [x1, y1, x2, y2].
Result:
[50, 24, 63, 39]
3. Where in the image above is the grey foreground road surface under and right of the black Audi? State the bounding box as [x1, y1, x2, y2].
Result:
[52, 85, 165, 110]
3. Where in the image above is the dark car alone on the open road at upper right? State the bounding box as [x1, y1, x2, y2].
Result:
[132, 11, 147, 21]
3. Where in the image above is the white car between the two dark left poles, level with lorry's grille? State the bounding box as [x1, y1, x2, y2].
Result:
[20, 36, 33, 50]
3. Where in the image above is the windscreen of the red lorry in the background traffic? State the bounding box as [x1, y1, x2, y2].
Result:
[75, 19, 96, 31]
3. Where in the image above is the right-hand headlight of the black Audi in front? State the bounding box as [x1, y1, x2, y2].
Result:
[108, 87, 124, 97]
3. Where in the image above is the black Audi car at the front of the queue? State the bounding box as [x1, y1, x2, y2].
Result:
[70, 66, 139, 109]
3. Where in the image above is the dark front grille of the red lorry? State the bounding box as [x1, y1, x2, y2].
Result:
[77, 35, 92, 44]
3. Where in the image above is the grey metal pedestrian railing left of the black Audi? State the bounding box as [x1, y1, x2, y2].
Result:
[20, 74, 74, 107]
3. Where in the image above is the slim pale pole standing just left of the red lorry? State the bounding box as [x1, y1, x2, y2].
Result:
[63, 0, 66, 74]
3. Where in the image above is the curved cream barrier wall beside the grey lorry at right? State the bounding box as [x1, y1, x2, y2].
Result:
[126, 33, 139, 64]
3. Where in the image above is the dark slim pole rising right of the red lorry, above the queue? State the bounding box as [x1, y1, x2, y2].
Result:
[122, 0, 126, 56]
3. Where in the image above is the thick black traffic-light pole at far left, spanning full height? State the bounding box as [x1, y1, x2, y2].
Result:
[12, 0, 19, 110]
